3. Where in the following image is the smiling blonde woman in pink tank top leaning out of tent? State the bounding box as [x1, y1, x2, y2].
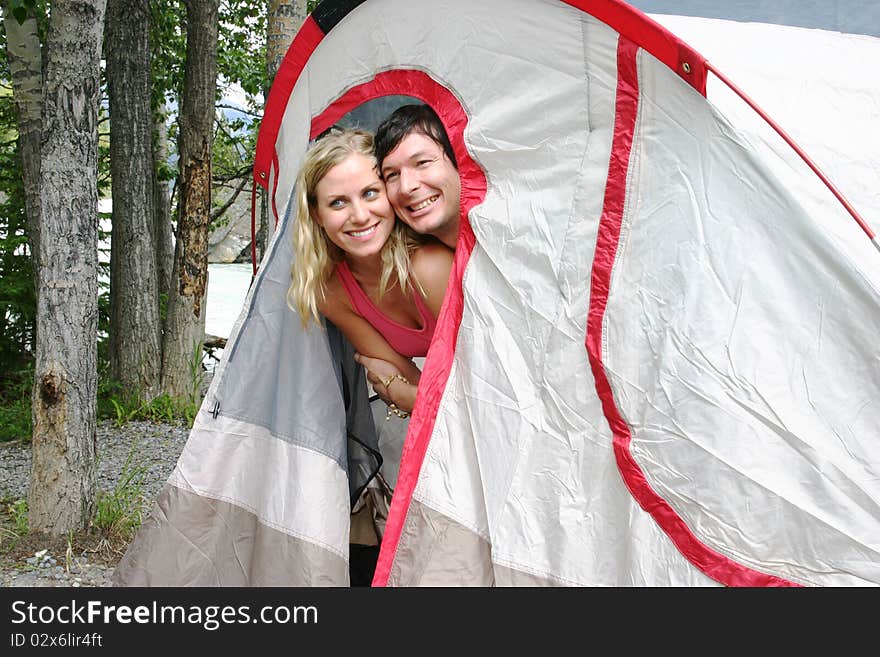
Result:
[287, 130, 453, 417]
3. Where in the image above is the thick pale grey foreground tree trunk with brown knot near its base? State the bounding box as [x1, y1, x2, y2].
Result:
[28, 0, 105, 535]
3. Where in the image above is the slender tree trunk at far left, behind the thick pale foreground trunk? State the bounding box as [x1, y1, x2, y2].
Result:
[3, 0, 43, 290]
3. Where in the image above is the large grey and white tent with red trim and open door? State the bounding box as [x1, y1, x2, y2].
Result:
[116, 0, 880, 586]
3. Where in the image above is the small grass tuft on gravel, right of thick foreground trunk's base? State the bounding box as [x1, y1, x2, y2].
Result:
[92, 443, 149, 540]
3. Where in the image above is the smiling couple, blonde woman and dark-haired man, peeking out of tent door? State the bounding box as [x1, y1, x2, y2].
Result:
[288, 105, 461, 426]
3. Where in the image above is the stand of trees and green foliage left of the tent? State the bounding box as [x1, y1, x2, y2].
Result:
[0, 0, 317, 536]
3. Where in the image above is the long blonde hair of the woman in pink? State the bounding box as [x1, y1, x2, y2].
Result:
[287, 129, 421, 326]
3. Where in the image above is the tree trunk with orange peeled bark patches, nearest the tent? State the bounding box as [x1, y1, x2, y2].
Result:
[162, 0, 218, 399]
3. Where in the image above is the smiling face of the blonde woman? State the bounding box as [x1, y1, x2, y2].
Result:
[314, 153, 395, 258]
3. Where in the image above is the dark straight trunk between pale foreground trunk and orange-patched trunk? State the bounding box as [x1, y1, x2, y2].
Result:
[105, 0, 162, 400]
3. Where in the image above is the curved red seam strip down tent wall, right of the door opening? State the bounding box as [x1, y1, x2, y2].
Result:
[585, 37, 795, 586]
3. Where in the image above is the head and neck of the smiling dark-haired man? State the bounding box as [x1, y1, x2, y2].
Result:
[374, 105, 461, 249]
